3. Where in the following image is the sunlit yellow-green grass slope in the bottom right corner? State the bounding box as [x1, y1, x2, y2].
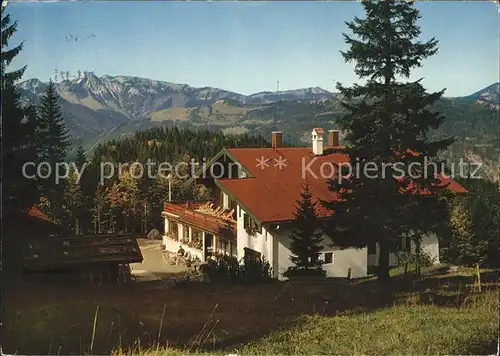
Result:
[237, 292, 498, 355]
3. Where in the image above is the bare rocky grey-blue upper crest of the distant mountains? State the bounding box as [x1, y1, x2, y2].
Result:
[18, 72, 333, 119]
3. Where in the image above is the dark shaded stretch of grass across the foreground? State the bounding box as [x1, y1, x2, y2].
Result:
[2, 271, 498, 354]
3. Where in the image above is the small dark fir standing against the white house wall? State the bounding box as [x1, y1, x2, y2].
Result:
[286, 184, 325, 276]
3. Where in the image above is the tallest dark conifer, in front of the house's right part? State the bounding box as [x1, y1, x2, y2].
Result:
[325, 0, 452, 280]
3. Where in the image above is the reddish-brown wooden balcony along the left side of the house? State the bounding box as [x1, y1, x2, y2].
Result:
[163, 201, 236, 239]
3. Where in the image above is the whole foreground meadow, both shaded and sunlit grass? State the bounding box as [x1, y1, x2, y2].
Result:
[2, 266, 499, 355]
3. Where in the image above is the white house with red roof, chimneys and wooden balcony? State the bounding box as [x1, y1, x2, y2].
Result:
[163, 128, 466, 279]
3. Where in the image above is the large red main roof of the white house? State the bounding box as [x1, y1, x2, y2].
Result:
[217, 147, 467, 222]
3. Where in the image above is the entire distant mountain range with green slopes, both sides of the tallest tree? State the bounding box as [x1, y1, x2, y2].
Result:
[18, 72, 500, 182]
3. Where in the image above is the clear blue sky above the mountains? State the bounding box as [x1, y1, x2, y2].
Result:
[7, 0, 500, 96]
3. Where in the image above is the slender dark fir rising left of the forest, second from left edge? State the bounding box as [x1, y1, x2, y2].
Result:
[35, 82, 70, 220]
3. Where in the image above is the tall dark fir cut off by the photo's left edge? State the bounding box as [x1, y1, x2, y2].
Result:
[1, 6, 38, 214]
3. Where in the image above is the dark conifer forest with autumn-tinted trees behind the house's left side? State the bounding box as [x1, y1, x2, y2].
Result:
[64, 127, 269, 233]
